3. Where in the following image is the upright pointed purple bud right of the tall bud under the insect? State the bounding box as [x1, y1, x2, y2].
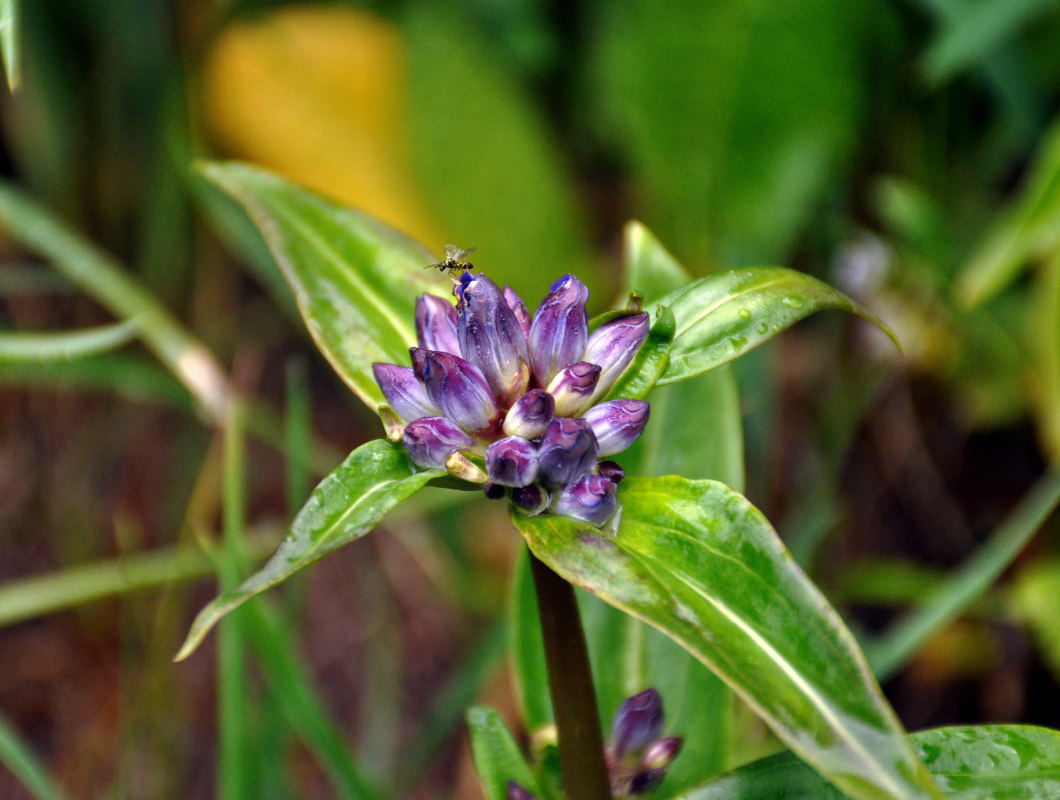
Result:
[530, 274, 589, 386]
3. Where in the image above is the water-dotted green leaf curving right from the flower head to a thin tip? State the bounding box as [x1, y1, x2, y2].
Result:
[658, 267, 898, 386]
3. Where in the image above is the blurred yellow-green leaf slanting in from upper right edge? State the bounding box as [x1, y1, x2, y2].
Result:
[956, 121, 1060, 307]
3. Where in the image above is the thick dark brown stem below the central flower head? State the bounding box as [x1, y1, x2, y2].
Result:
[530, 553, 612, 800]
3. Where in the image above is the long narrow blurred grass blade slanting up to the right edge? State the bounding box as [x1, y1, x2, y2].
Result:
[865, 473, 1060, 680]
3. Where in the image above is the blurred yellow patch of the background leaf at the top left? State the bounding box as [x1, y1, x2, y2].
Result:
[202, 4, 442, 246]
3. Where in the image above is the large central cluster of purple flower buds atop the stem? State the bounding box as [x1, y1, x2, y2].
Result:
[372, 271, 649, 526]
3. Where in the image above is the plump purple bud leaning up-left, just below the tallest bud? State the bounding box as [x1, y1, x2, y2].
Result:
[409, 348, 497, 433]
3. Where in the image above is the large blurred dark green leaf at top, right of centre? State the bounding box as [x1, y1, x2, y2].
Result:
[583, 0, 868, 270]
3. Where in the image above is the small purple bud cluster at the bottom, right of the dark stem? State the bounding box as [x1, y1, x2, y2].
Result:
[606, 689, 683, 800]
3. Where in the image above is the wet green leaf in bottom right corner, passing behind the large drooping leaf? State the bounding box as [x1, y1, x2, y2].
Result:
[683, 725, 1060, 800]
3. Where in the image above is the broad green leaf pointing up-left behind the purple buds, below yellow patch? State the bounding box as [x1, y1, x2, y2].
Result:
[201, 163, 446, 409]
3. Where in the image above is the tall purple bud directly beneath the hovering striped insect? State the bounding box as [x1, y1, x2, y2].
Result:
[456, 272, 530, 406]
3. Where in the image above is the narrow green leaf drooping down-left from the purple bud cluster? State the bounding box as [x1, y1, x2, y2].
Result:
[176, 439, 445, 661]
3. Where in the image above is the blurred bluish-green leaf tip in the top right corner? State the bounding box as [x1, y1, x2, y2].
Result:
[922, 0, 1056, 85]
